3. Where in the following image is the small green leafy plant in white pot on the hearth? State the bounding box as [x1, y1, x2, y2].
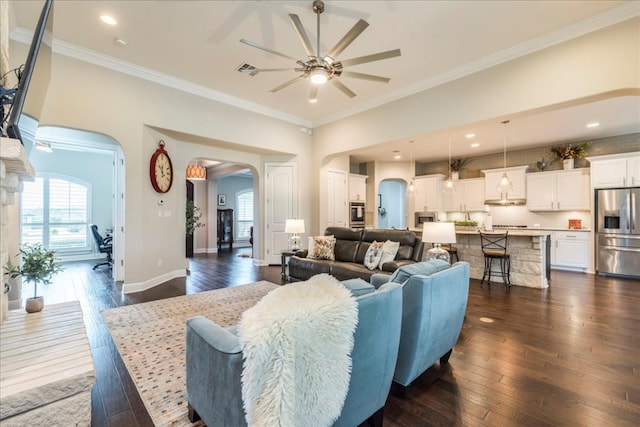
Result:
[5, 243, 62, 313]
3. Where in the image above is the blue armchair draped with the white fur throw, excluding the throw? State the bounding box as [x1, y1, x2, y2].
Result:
[186, 276, 402, 427]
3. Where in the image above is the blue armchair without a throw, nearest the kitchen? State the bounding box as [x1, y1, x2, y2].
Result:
[371, 260, 469, 395]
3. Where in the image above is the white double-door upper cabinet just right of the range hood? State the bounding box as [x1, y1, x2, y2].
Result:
[527, 169, 590, 211]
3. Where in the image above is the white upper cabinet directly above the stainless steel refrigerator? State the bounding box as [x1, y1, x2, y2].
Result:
[588, 152, 640, 188]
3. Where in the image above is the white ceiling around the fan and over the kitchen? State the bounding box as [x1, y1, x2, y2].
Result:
[11, 0, 640, 161]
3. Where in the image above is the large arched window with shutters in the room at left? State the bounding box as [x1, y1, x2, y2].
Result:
[20, 175, 91, 252]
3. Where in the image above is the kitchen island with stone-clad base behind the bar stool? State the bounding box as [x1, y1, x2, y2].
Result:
[454, 228, 551, 288]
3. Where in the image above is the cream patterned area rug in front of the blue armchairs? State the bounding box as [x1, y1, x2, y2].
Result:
[102, 281, 280, 426]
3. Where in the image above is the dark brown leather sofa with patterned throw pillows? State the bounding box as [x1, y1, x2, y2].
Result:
[289, 227, 423, 281]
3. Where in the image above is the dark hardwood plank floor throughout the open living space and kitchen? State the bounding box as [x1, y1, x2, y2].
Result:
[27, 248, 640, 427]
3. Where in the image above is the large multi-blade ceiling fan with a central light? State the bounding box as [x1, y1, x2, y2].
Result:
[240, 0, 400, 102]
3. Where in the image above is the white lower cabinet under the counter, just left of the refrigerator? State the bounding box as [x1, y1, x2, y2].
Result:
[551, 231, 589, 268]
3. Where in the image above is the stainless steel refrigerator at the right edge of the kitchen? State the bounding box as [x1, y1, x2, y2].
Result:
[595, 187, 640, 278]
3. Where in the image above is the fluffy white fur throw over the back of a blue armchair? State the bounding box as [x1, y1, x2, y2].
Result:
[238, 274, 358, 427]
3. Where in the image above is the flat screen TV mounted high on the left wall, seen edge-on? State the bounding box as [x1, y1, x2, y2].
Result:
[6, 0, 53, 153]
